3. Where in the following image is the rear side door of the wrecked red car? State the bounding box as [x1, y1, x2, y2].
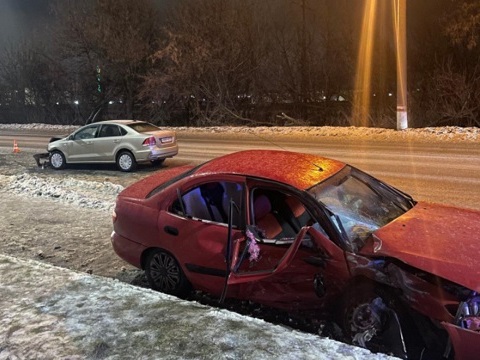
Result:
[159, 179, 244, 296]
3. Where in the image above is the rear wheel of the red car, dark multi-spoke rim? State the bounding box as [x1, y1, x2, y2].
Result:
[145, 249, 191, 297]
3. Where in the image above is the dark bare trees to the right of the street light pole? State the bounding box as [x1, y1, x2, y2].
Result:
[410, 0, 480, 126]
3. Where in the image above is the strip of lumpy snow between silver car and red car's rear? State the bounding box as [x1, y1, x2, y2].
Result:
[0, 174, 123, 212]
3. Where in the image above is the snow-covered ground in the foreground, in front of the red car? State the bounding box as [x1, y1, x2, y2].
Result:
[0, 255, 393, 360]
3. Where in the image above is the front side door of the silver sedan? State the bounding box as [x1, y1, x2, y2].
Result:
[66, 124, 99, 162]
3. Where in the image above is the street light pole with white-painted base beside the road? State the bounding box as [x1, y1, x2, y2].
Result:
[394, 0, 408, 130]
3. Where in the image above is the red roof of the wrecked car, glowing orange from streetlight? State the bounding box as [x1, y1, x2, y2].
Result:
[195, 150, 346, 190]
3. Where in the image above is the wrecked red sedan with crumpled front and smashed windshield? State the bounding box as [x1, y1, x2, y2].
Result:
[112, 150, 480, 359]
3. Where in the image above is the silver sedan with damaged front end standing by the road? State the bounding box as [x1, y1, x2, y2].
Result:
[47, 120, 178, 171]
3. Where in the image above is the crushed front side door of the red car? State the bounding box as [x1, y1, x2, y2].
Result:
[228, 183, 349, 309]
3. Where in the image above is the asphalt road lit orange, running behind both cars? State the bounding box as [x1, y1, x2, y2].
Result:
[0, 130, 480, 210]
